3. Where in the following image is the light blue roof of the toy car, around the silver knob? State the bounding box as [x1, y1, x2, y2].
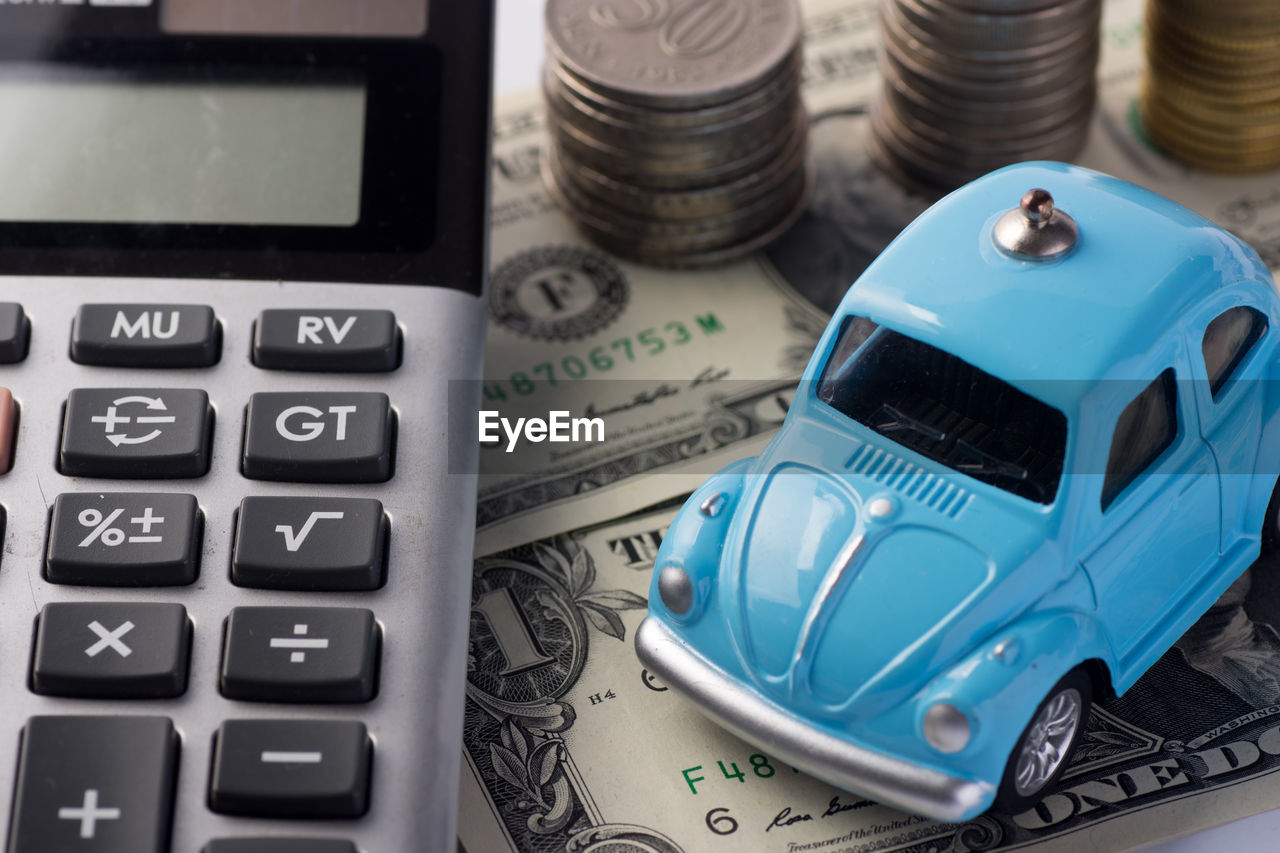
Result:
[838, 163, 1270, 414]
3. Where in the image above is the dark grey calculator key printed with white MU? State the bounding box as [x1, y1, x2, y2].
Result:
[72, 305, 221, 368]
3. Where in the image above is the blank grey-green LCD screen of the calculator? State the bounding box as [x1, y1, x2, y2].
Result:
[0, 65, 366, 227]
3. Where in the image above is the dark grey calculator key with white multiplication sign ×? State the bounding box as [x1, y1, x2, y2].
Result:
[31, 602, 191, 699]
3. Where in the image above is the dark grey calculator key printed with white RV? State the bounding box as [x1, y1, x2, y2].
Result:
[253, 309, 401, 373]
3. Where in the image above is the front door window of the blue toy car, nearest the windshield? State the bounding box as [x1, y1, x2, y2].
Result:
[1102, 368, 1178, 512]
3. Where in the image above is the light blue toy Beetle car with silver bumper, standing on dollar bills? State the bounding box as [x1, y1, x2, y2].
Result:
[636, 163, 1280, 821]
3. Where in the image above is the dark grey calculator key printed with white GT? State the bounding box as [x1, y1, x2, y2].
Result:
[241, 392, 394, 483]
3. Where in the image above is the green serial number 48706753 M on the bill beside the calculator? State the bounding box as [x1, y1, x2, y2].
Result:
[484, 313, 724, 402]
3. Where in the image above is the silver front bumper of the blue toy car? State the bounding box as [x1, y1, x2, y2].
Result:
[636, 616, 996, 822]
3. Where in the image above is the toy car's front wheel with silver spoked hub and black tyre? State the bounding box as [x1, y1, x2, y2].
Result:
[996, 669, 1093, 813]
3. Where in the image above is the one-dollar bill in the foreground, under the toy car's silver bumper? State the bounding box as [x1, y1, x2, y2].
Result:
[460, 510, 1280, 853]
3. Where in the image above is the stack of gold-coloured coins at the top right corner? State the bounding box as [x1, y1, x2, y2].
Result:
[1142, 0, 1280, 173]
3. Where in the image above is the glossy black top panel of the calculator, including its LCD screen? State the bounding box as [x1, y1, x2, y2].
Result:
[0, 0, 494, 293]
